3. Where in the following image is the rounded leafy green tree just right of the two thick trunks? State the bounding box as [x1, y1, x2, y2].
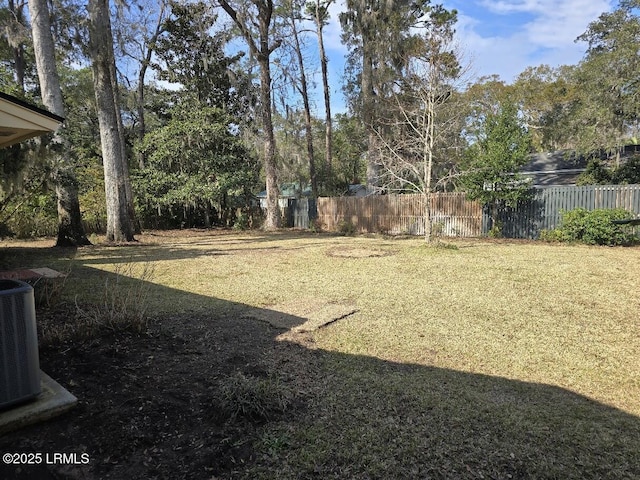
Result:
[132, 106, 259, 227]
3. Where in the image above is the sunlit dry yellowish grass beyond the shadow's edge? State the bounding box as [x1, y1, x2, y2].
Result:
[76, 232, 640, 415]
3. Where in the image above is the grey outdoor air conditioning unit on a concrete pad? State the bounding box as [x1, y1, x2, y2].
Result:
[0, 280, 40, 409]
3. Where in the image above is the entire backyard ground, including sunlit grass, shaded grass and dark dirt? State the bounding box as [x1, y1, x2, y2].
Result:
[0, 231, 640, 479]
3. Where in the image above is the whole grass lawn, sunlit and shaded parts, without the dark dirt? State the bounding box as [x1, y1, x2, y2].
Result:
[0, 232, 640, 479]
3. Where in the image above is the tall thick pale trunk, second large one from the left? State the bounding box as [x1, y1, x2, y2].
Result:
[87, 0, 134, 242]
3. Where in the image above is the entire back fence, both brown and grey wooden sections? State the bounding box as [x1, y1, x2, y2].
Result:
[280, 185, 640, 239]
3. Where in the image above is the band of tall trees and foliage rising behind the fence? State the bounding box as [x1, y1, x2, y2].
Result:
[0, 0, 640, 239]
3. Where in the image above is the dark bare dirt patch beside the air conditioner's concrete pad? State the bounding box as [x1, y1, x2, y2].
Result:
[0, 309, 320, 480]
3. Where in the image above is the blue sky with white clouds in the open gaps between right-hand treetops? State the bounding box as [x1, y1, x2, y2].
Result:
[316, 0, 617, 116]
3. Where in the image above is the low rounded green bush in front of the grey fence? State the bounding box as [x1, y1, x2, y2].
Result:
[540, 208, 638, 246]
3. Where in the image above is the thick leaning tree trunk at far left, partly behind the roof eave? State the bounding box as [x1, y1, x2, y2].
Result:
[29, 0, 91, 246]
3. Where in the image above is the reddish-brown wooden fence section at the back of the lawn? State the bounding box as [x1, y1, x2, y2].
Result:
[318, 193, 482, 237]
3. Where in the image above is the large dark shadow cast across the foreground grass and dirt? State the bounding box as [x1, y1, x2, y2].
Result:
[0, 244, 640, 479]
